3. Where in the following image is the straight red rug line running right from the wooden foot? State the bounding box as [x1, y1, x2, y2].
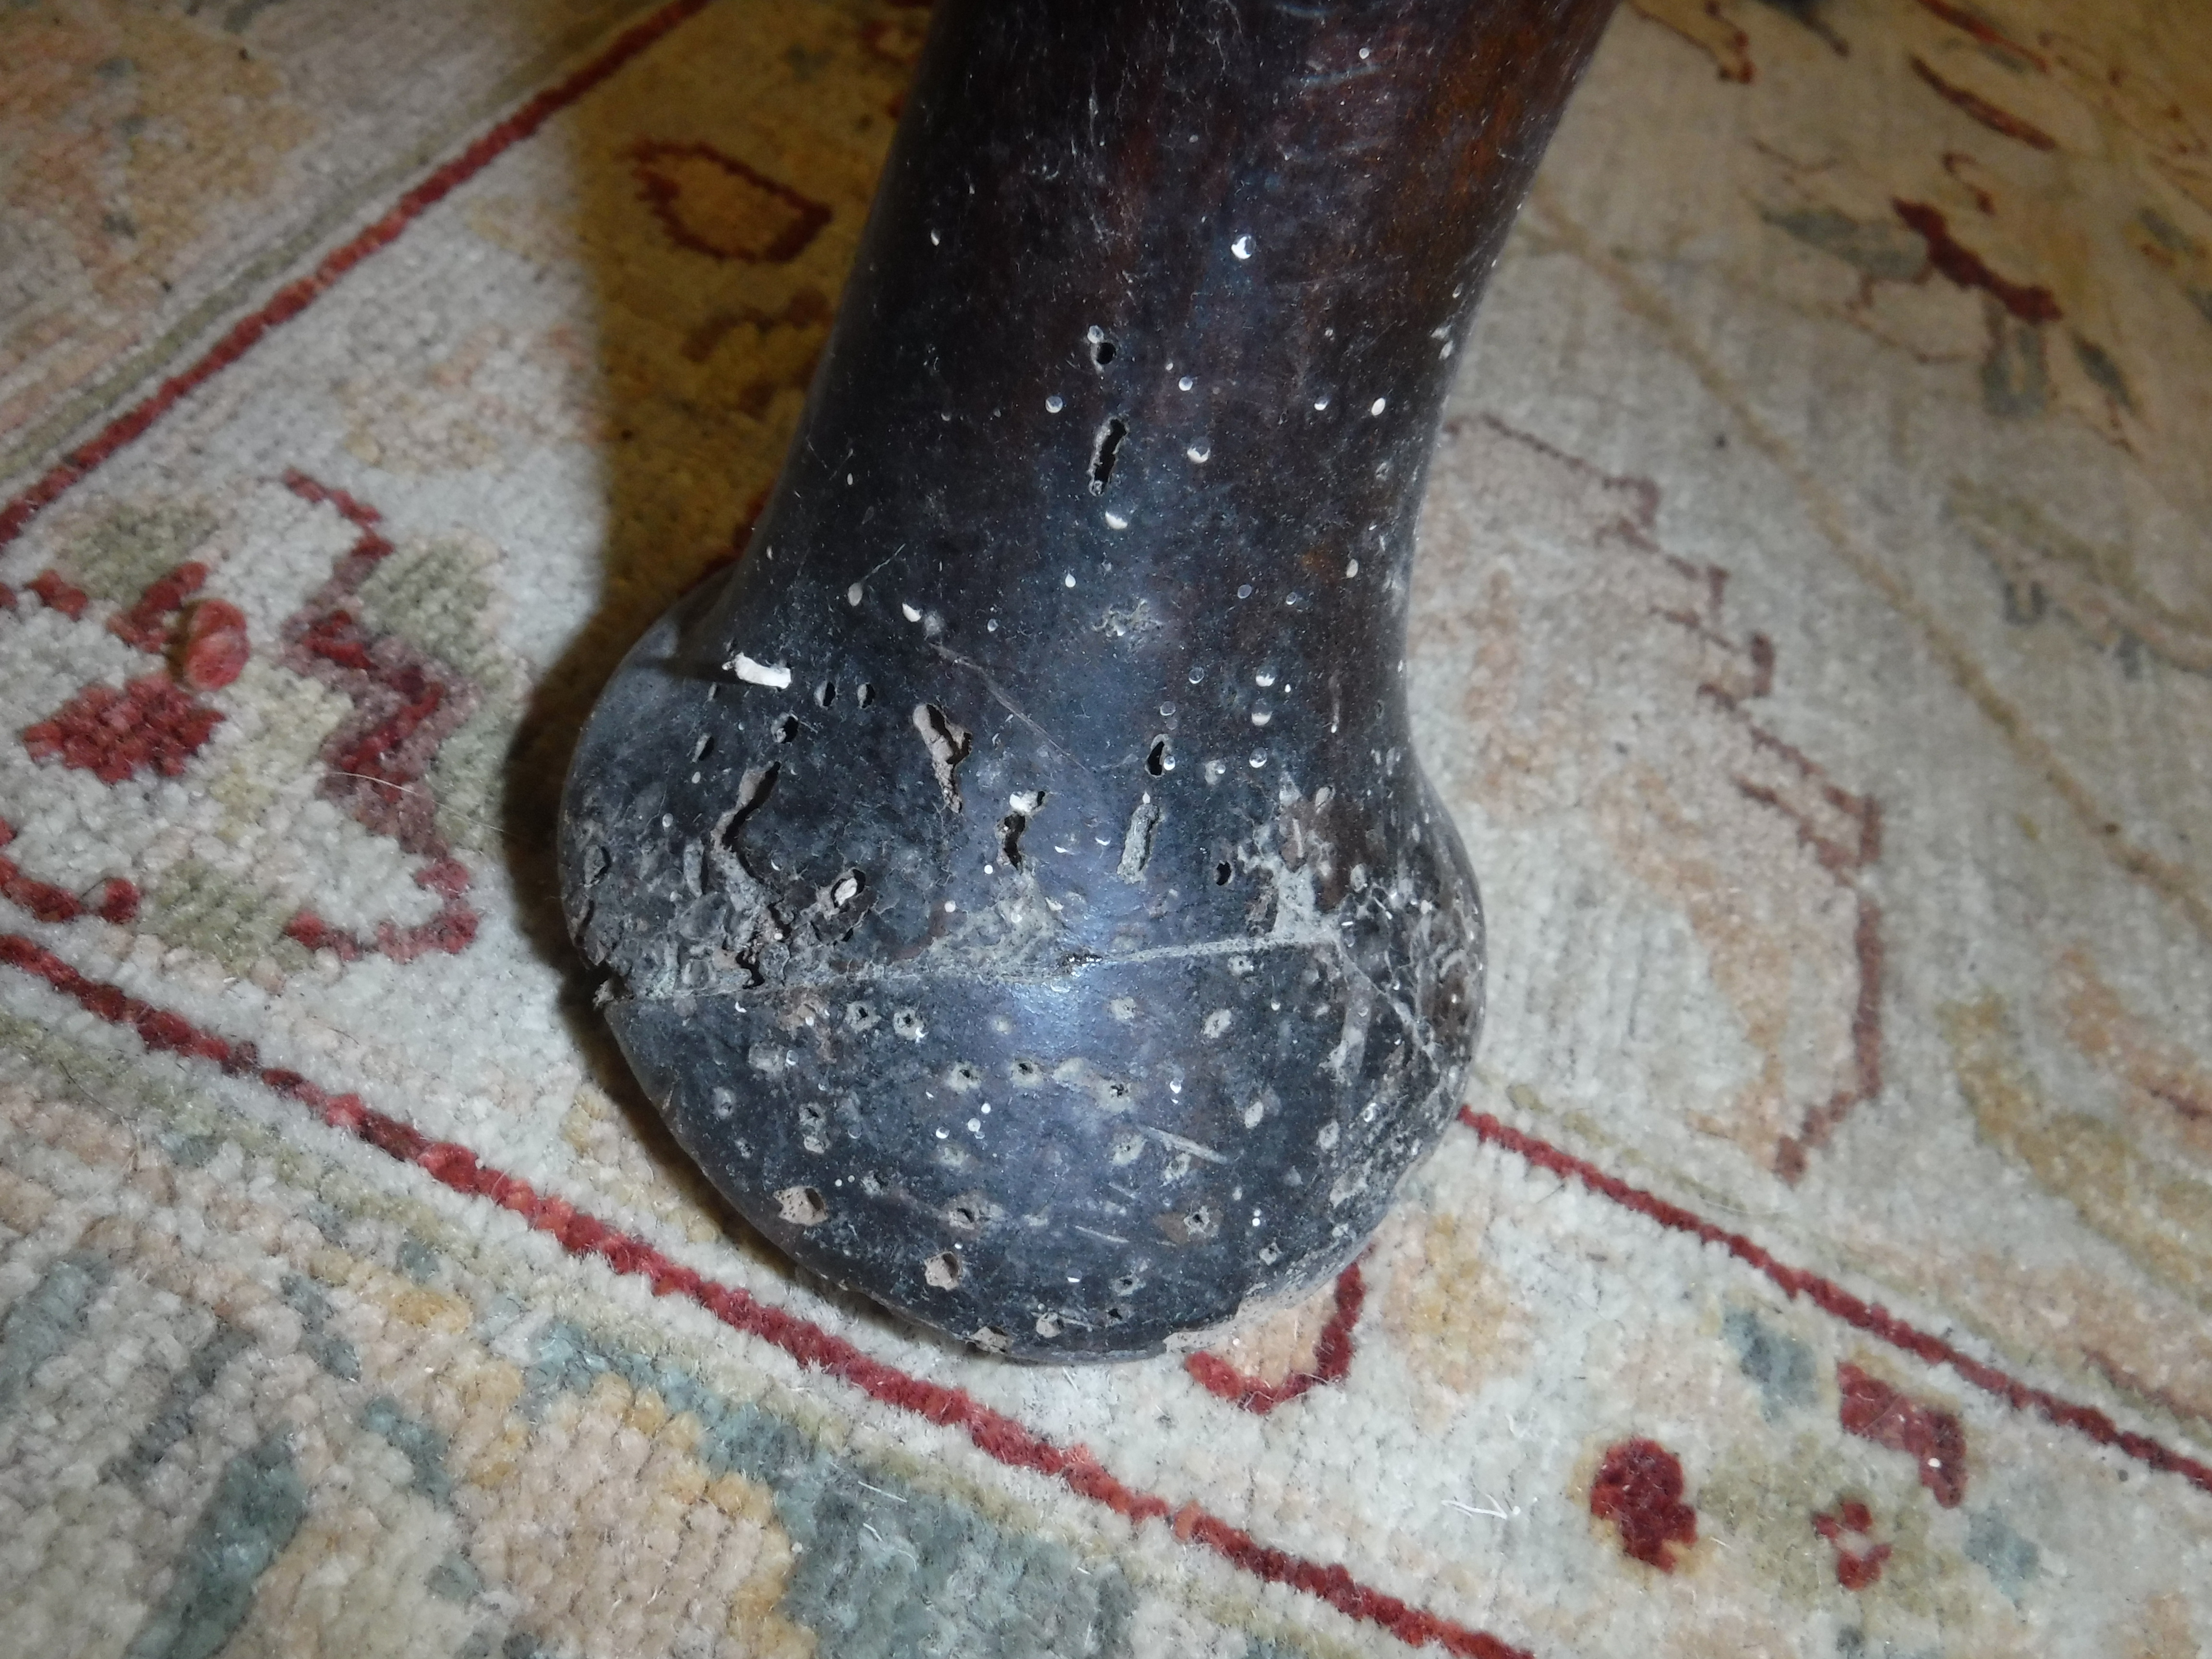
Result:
[1460, 1106, 2212, 1493]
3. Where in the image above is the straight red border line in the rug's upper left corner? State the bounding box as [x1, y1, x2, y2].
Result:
[0, 0, 708, 549]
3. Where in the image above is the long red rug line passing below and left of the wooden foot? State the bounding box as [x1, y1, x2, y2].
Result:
[0, 934, 1533, 1659]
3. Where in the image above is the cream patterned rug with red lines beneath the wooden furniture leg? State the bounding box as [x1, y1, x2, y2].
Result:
[0, 0, 2212, 1659]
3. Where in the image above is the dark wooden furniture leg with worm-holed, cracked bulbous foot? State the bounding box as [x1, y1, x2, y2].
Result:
[562, 0, 1611, 1360]
